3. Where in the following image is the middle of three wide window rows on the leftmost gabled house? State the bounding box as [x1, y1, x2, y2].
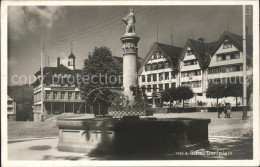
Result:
[142, 71, 176, 82]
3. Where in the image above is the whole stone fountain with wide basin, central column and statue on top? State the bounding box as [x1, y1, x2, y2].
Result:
[57, 9, 210, 155]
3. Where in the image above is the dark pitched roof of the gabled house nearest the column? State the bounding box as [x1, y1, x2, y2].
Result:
[138, 42, 182, 75]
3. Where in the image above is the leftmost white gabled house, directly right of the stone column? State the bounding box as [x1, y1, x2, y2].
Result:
[138, 42, 182, 104]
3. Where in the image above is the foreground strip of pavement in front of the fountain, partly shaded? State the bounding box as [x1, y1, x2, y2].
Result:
[8, 137, 252, 160]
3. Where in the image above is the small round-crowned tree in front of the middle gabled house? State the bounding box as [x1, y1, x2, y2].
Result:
[175, 86, 194, 108]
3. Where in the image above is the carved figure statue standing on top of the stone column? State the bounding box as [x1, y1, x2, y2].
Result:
[122, 9, 135, 35]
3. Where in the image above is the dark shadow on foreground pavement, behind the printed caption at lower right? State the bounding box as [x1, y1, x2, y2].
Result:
[85, 138, 253, 160]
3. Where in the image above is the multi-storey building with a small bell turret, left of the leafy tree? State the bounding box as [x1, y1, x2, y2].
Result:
[33, 49, 84, 121]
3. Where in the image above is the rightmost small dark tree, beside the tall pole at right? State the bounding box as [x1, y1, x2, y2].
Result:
[225, 83, 243, 107]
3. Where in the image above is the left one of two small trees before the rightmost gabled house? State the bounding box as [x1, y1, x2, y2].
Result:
[206, 83, 226, 104]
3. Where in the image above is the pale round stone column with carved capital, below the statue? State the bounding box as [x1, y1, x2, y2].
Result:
[120, 35, 140, 104]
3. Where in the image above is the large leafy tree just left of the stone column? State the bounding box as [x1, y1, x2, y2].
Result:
[80, 47, 123, 115]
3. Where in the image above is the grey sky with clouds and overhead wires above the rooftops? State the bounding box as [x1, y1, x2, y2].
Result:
[8, 6, 252, 85]
